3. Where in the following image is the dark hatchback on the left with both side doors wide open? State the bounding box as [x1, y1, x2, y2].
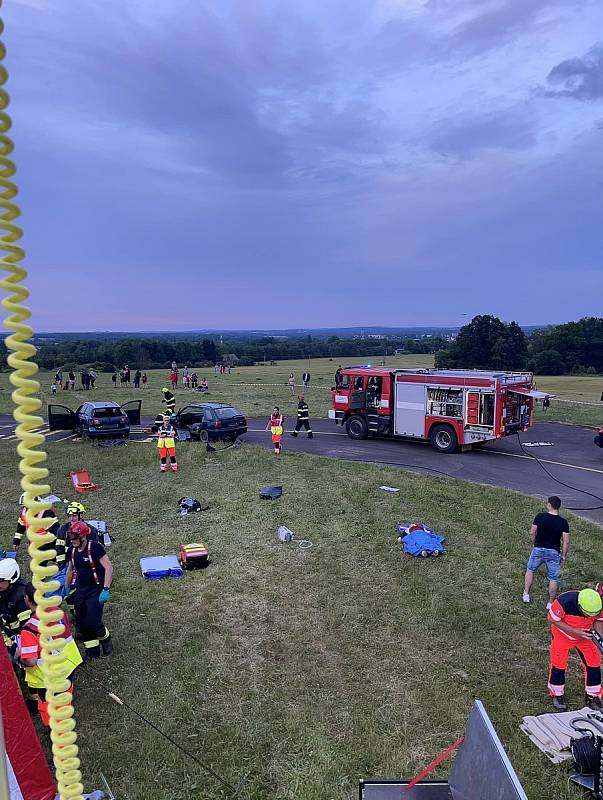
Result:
[48, 400, 142, 439]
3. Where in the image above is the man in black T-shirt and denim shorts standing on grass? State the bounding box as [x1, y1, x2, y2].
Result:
[523, 495, 569, 608]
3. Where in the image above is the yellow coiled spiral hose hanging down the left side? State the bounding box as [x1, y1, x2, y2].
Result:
[0, 10, 83, 800]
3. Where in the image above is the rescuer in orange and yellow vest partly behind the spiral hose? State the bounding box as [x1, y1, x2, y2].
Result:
[17, 583, 82, 727]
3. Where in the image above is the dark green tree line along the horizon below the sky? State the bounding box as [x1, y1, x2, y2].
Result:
[0, 315, 603, 375]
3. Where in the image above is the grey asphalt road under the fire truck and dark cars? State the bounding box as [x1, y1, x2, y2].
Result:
[0, 416, 603, 526]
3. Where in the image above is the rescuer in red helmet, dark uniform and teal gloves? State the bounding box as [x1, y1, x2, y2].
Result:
[65, 521, 113, 661]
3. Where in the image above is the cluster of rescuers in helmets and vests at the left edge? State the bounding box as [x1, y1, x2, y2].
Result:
[0, 494, 113, 725]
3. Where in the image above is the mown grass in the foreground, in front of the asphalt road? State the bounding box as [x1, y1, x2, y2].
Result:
[0, 434, 603, 800]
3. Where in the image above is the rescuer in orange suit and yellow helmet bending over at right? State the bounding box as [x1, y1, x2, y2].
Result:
[548, 589, 603, 711]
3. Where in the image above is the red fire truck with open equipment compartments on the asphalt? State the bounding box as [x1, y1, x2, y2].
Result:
[329, 365, 547, 453]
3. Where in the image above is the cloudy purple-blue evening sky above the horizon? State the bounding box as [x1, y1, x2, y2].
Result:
[2, 0, 603, 331]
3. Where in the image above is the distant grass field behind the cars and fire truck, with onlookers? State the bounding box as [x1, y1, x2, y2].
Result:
[0, 355, 603, 427]
